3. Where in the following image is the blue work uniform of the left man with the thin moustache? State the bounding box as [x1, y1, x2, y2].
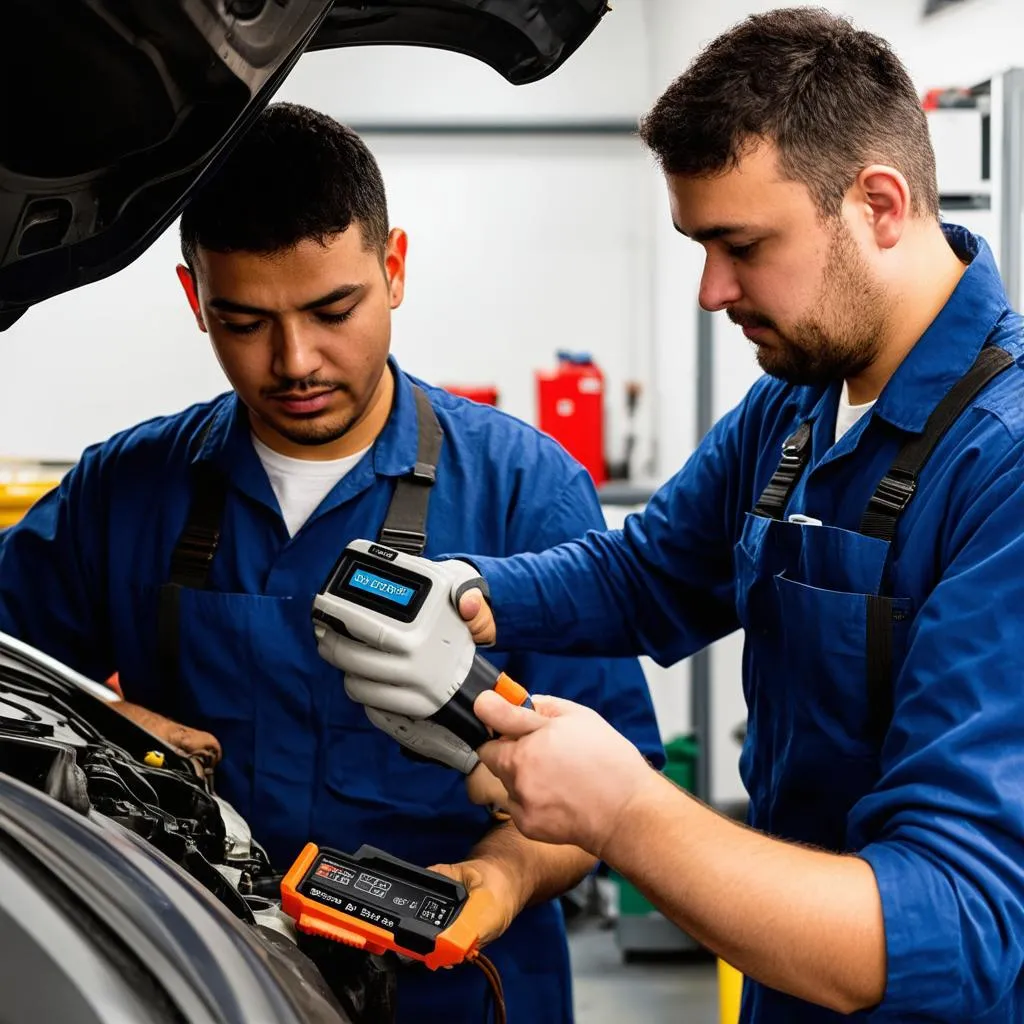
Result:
[0, 362, 663, 1024]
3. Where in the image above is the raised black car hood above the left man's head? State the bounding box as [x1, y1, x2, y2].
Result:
[0, 0, 607, 330]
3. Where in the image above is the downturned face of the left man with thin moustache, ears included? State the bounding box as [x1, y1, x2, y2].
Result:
[179, 223, 407, 454]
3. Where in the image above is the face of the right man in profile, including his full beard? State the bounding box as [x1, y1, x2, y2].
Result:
[669, 143, 891, 384]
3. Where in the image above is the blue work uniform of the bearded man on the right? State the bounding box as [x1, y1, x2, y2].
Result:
[473, 225, 1024, 1024]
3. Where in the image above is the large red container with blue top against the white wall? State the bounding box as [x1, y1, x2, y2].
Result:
[537, 351, 608, 485]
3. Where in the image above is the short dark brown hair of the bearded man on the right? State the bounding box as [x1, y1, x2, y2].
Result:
[640, 7, 939, 217]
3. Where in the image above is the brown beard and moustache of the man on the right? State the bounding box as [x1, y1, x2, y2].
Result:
[727, 220, 889, 386]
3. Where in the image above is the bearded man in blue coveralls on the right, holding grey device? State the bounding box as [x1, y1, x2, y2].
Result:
[331, 8, 1024, 1024]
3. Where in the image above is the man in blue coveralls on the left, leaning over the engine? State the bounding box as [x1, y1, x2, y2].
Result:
[0, 104, 662, 1024]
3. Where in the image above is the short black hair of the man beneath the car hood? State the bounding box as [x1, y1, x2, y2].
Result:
[180, 103, 388, 267]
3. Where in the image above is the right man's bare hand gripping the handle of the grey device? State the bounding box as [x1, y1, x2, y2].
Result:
[474, 690, 658, 857]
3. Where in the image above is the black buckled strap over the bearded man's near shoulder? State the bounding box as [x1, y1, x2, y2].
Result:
[860, 345, 1014, 541]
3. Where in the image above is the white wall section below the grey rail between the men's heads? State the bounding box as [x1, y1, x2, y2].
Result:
[368, 135, 650, 464]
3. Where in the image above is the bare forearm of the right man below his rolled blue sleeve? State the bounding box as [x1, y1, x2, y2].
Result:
[602, 773, 886, 1013]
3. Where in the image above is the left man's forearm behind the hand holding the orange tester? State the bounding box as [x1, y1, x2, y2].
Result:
[467, 821, 597, 913]
